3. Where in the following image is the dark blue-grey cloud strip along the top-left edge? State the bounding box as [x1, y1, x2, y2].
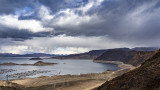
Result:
[0, 0, 88, 14]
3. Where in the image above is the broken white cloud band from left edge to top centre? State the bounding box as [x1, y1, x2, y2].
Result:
[0, 0, 103, 32]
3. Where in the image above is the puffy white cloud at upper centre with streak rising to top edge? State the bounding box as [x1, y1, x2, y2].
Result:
[52, 0, 104, 27]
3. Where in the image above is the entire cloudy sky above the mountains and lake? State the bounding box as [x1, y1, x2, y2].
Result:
[0, 0, 160, 54]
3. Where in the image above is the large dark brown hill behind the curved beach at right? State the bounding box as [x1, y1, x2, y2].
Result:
[95, 49, 153, 66]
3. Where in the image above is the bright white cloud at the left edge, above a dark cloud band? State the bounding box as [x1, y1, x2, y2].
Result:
[0, 15, 52, 32]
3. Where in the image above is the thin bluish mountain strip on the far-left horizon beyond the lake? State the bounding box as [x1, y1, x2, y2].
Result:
[0, 53, 60, 57]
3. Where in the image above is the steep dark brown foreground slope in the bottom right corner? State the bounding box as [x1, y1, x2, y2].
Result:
[98, 50, 160, 90]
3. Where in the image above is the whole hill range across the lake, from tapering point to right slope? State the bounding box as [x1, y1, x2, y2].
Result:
[52, 47, 158, 66]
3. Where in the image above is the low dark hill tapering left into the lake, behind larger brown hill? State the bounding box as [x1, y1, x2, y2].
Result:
[52, 50, 109, 60]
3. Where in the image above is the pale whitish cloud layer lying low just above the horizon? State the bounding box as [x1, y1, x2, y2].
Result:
[0, 35, 133, 54]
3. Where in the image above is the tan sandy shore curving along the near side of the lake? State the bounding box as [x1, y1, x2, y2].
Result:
[0, 62, 134, 90]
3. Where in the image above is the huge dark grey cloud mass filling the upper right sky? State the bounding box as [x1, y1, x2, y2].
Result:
[49, 0, 160, 44]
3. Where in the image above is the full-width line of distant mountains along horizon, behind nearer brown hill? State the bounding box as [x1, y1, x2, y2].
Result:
[0, 47, 156, 60]
